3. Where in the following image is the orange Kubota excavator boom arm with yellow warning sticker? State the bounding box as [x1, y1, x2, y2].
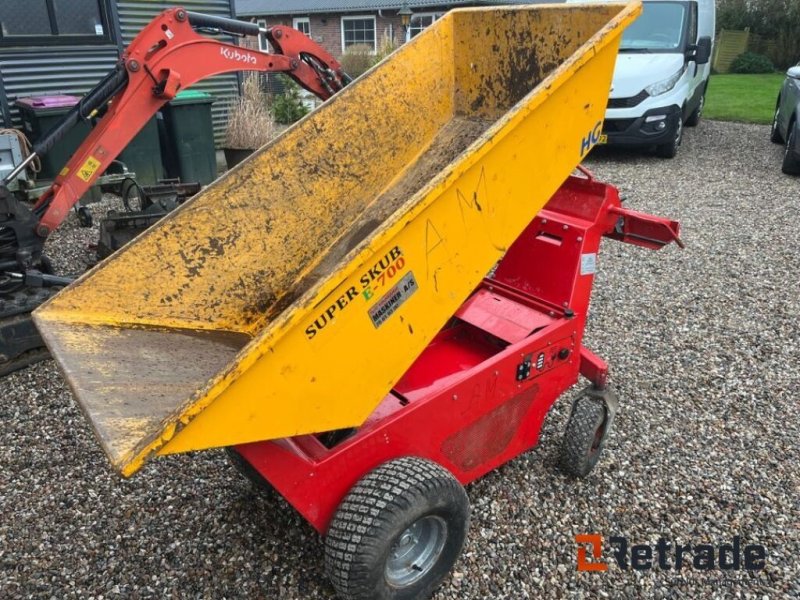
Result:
[34, 8, 349, 238]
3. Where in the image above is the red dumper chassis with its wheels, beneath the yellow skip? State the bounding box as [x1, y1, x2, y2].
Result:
[230, 170, 680, 599]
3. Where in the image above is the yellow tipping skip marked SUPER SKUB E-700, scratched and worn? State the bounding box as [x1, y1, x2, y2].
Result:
[35, 3, 641, 476]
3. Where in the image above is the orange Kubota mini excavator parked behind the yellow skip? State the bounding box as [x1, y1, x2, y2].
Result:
[0, 8, 350, 376]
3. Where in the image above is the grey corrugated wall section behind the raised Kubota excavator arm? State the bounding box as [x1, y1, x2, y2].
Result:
[115, 0, 239, 145]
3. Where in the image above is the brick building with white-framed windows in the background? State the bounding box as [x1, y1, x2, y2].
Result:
[235, 0, 532, 58]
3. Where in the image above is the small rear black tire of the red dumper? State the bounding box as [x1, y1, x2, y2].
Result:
[559, 396, 608, 477]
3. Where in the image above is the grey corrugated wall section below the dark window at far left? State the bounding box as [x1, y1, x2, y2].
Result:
[0, 45, 119, 126]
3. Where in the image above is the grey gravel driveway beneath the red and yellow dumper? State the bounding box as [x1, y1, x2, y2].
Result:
[0, 121, 800, 600]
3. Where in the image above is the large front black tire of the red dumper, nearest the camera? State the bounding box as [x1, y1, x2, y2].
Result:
[325, 457, 469, 600]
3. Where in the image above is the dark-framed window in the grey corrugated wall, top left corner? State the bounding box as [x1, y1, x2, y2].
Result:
[0, 0, 111, 46]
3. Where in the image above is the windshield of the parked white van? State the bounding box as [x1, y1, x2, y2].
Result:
[619, 2, 686, 52]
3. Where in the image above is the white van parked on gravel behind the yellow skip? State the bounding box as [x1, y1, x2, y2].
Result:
[567, 0, 716, 158]
